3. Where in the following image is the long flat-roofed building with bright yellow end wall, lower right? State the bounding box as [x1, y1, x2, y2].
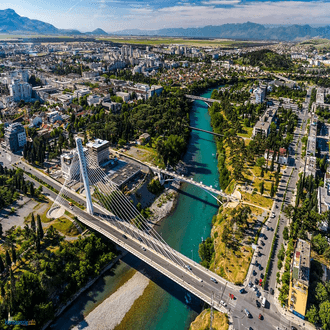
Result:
[288, 239, 311, 319]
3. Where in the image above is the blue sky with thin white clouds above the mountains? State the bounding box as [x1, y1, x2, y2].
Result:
[0, 0, 330, 32]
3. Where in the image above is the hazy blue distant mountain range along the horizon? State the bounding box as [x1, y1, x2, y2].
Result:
[0, 9, 330, 41]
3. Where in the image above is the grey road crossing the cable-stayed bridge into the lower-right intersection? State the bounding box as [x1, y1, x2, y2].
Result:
[2, 158, 302, 330]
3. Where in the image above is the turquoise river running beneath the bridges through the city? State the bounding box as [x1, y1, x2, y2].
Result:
[53, 88, 219, 330]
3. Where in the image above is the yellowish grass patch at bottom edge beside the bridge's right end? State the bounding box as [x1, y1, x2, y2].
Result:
[189, 308, 229, 330]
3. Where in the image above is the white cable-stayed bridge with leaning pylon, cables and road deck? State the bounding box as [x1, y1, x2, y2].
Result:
[50, 138, 238, 311]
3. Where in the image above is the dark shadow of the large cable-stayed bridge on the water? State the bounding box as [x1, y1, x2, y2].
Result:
[121, 253, 203, 313]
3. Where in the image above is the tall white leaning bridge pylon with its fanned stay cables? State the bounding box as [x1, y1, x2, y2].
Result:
[50, 142, 193, 274]
